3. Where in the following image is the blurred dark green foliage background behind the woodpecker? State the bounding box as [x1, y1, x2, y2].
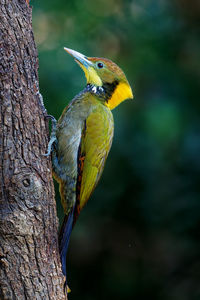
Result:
[32, 0, 200, 300]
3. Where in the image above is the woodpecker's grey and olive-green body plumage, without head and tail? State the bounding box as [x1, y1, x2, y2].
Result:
[54, 90, 114, 214]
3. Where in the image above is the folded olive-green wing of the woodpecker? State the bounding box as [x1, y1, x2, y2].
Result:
[75, 105, 114, 223]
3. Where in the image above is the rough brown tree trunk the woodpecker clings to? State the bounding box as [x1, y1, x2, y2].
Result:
[0, 0, 67, 300]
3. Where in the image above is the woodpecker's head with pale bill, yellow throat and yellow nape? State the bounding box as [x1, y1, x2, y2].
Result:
[64, 48, 133, 109]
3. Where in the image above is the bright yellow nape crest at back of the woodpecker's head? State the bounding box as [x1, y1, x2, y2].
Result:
[106, 82, 133, 109]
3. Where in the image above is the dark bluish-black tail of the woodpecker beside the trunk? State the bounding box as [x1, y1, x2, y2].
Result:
[59, 209, 74, 286]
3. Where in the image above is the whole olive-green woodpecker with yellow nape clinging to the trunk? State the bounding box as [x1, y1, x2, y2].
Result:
[46, 48, 133, 292]
